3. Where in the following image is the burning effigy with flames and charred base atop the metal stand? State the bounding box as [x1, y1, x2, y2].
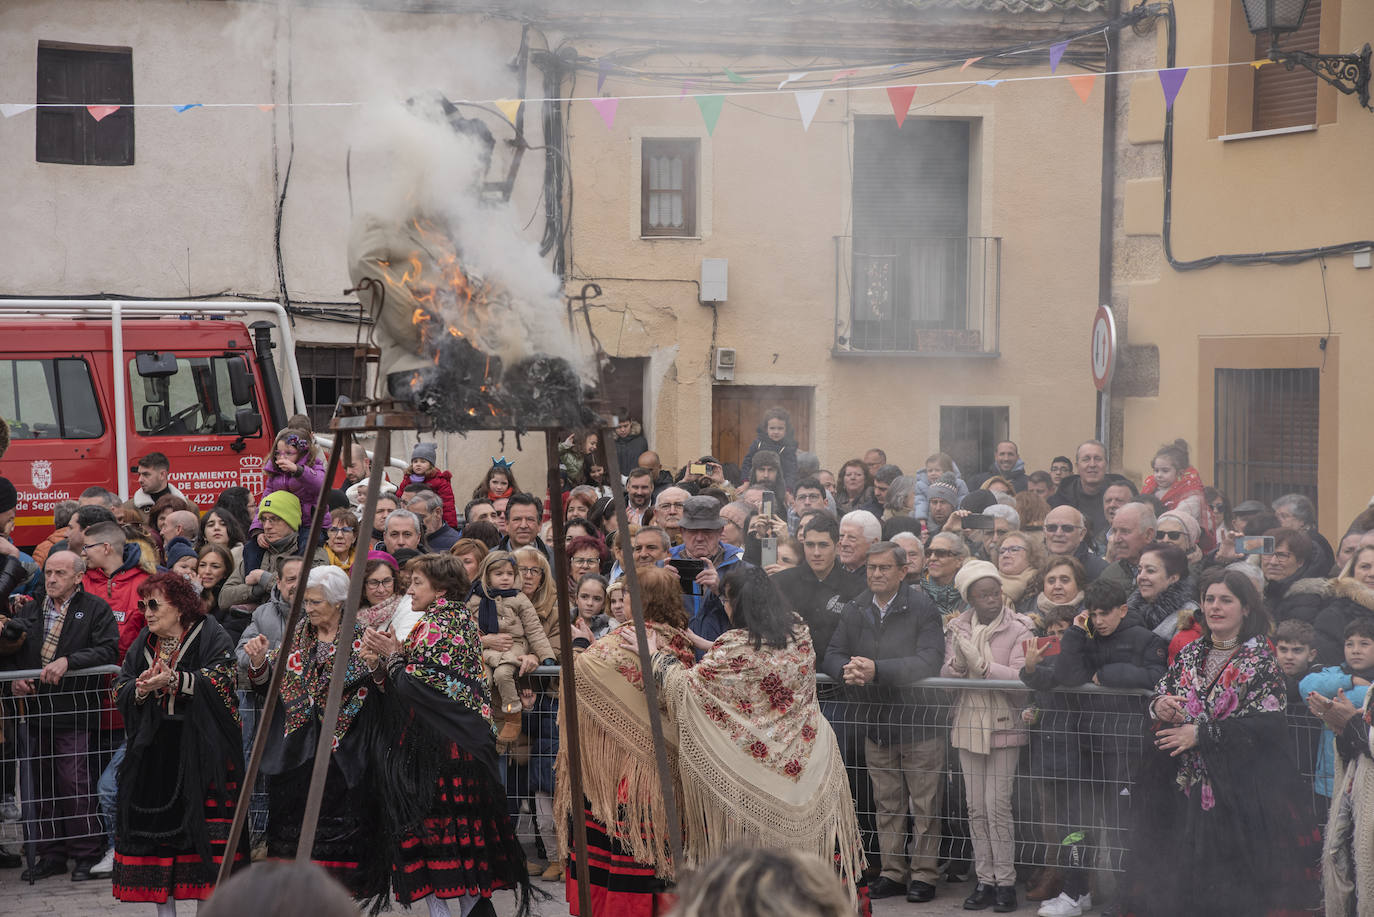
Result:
[348, 99, 596, 433]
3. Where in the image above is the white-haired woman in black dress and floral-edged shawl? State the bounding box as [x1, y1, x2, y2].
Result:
[243, 566, 379, 898]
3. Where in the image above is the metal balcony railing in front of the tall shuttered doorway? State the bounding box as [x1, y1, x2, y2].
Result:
[833, 235, 1002, 357]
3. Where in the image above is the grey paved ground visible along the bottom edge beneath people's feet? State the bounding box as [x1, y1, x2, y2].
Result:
[0, 869, 1000, 917]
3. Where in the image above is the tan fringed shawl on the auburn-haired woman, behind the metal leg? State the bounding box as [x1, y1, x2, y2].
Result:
[554, 623, 695, 880]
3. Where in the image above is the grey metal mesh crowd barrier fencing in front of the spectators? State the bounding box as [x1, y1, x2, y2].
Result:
[0, 665, 1326, 876]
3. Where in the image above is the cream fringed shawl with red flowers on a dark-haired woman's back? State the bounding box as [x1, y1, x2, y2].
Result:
[654, 626, 863, 895]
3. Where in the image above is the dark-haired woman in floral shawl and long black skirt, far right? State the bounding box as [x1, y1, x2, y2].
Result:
[1121, 569, 1320, 917]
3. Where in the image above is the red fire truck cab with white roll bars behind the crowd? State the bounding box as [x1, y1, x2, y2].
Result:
[0, 300, 304, 546]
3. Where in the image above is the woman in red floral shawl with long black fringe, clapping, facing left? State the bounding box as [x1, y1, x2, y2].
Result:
[363, 554, 530, 917]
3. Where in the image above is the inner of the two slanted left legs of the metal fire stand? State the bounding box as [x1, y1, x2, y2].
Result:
[295, 429, 392, 863]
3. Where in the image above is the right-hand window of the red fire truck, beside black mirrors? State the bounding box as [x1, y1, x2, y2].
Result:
[129, 356, 256, 436]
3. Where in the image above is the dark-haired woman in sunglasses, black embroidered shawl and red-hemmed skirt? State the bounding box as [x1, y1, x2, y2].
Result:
[114, 573, 249, 916]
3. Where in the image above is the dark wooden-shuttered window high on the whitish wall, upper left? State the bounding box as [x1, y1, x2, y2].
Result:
[36, 41, 133, 165]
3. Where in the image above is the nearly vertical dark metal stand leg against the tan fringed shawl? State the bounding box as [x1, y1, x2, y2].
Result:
[544, 430, 592, 916]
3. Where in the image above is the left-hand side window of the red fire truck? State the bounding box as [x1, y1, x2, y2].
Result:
[0, 357, 104, 440]
